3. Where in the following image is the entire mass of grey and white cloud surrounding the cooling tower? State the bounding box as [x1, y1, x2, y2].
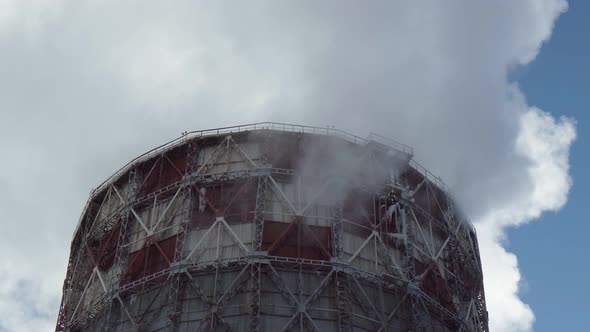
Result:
[0, 0, 575, 331]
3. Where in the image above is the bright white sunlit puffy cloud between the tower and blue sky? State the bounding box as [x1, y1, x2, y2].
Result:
[477, 107, 576, 331]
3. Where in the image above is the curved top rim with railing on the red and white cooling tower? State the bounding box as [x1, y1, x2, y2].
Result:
[74, 122, 475, 239]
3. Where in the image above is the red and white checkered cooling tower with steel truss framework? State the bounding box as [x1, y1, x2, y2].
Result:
[56, 123, 488, 331]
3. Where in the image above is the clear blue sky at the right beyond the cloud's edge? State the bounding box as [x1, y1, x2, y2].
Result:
[508, 0, 590, 332]
